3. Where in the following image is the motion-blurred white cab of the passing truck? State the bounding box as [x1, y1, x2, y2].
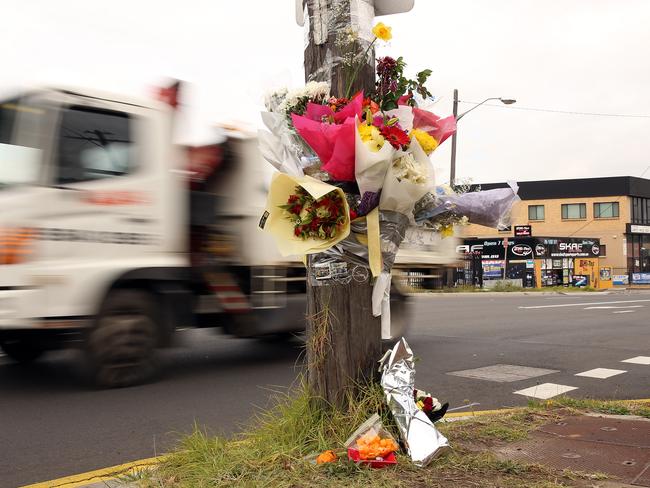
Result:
[0, 89, 189, 384]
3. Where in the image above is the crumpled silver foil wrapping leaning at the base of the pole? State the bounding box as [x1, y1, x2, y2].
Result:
[380, 337, 449, 466]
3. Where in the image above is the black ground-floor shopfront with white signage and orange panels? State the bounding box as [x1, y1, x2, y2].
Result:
[459, 237, 611, 288]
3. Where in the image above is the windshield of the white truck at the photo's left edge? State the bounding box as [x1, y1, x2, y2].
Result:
[0, 99, 45, 189]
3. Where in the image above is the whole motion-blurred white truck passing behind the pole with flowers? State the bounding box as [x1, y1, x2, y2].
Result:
[0, 86, 453, 387]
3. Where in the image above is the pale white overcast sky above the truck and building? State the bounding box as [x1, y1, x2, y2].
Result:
[0, 0, 650, 182]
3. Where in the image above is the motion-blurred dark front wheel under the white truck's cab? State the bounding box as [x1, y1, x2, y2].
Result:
[86, 290, 159, 388]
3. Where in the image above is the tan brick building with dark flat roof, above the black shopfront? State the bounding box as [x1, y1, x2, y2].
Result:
[461, 176, 650, 284]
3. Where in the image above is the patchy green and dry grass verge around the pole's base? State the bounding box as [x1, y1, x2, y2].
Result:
[132, 386, 624, 488]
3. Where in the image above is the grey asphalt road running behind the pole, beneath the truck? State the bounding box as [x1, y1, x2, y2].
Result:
[0, 292, 650, 487]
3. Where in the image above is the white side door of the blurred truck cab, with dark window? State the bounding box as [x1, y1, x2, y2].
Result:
[29, 94, 173, 316]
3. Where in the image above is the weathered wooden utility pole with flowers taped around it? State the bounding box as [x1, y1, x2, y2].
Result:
[305, 0, 382, 407]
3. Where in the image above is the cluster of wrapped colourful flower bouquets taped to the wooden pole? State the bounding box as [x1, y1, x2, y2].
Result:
[260, 21, 516, 339]
